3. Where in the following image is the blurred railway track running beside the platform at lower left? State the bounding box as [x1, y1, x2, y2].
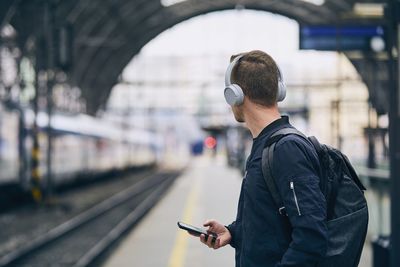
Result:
[0, 172, 179, 267]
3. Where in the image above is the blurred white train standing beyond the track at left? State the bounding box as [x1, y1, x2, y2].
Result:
[0, 102, 164, 189]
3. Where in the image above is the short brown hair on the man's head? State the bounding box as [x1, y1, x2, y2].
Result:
[231, 50, 281, 107]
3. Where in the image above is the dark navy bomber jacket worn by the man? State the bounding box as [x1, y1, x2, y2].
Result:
[228, 117, 327, 267]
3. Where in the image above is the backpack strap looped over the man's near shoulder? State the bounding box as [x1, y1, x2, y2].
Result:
[261, 127, 308, 215]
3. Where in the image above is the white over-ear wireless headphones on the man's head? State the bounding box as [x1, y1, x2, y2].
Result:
[224, 55, 286, 106]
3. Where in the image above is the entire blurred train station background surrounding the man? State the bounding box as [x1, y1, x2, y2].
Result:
[0, 0, 400, 267]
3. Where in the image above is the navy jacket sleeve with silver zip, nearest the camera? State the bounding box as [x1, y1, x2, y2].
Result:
[272, 136, 327, 267]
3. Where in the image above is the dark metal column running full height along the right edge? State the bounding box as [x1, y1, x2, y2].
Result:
[388, 0, 400, 267]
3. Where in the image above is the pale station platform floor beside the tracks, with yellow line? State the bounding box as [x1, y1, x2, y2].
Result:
[103, 155, 371, 267]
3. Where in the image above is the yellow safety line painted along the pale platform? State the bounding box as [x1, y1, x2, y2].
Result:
[168, 180, 199, 267]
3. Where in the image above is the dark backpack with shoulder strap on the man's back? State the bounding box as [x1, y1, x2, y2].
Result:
[262, 128, 368, 267]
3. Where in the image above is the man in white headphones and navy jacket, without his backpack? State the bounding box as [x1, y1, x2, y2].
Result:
[200, 51, 328, 267]
